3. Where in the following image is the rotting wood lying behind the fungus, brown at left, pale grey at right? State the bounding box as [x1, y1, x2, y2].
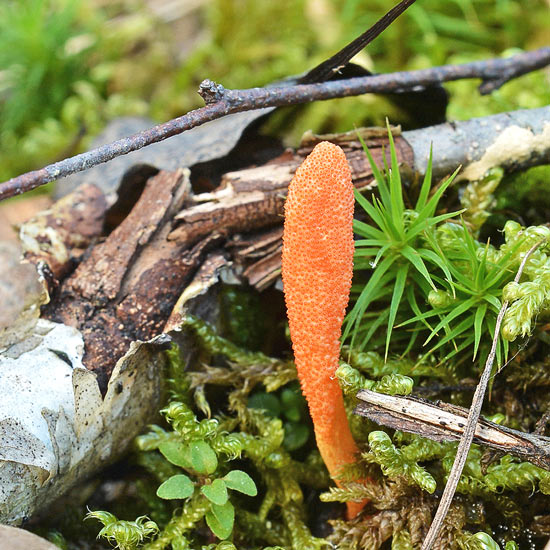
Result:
[19, 108, 550, 396]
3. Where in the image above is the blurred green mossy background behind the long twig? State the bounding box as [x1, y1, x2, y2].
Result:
[0, 0, 550, 180]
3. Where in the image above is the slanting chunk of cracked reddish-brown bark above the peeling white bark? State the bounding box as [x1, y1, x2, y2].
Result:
[44, 171, 195, 391]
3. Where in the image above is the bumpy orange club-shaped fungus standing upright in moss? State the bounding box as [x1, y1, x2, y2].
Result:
[283, 141, 363, 517]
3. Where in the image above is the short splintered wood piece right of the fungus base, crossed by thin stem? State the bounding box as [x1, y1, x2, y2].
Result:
[355, 390, 550, 470]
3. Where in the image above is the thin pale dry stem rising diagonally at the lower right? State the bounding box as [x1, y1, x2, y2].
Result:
[421, 241, 544, 550]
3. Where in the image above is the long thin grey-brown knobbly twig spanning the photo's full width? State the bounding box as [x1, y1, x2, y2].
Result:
[0, 47, 550, 200]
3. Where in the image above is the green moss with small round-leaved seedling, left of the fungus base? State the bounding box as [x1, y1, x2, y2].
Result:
[87, 318, 338, 550]
